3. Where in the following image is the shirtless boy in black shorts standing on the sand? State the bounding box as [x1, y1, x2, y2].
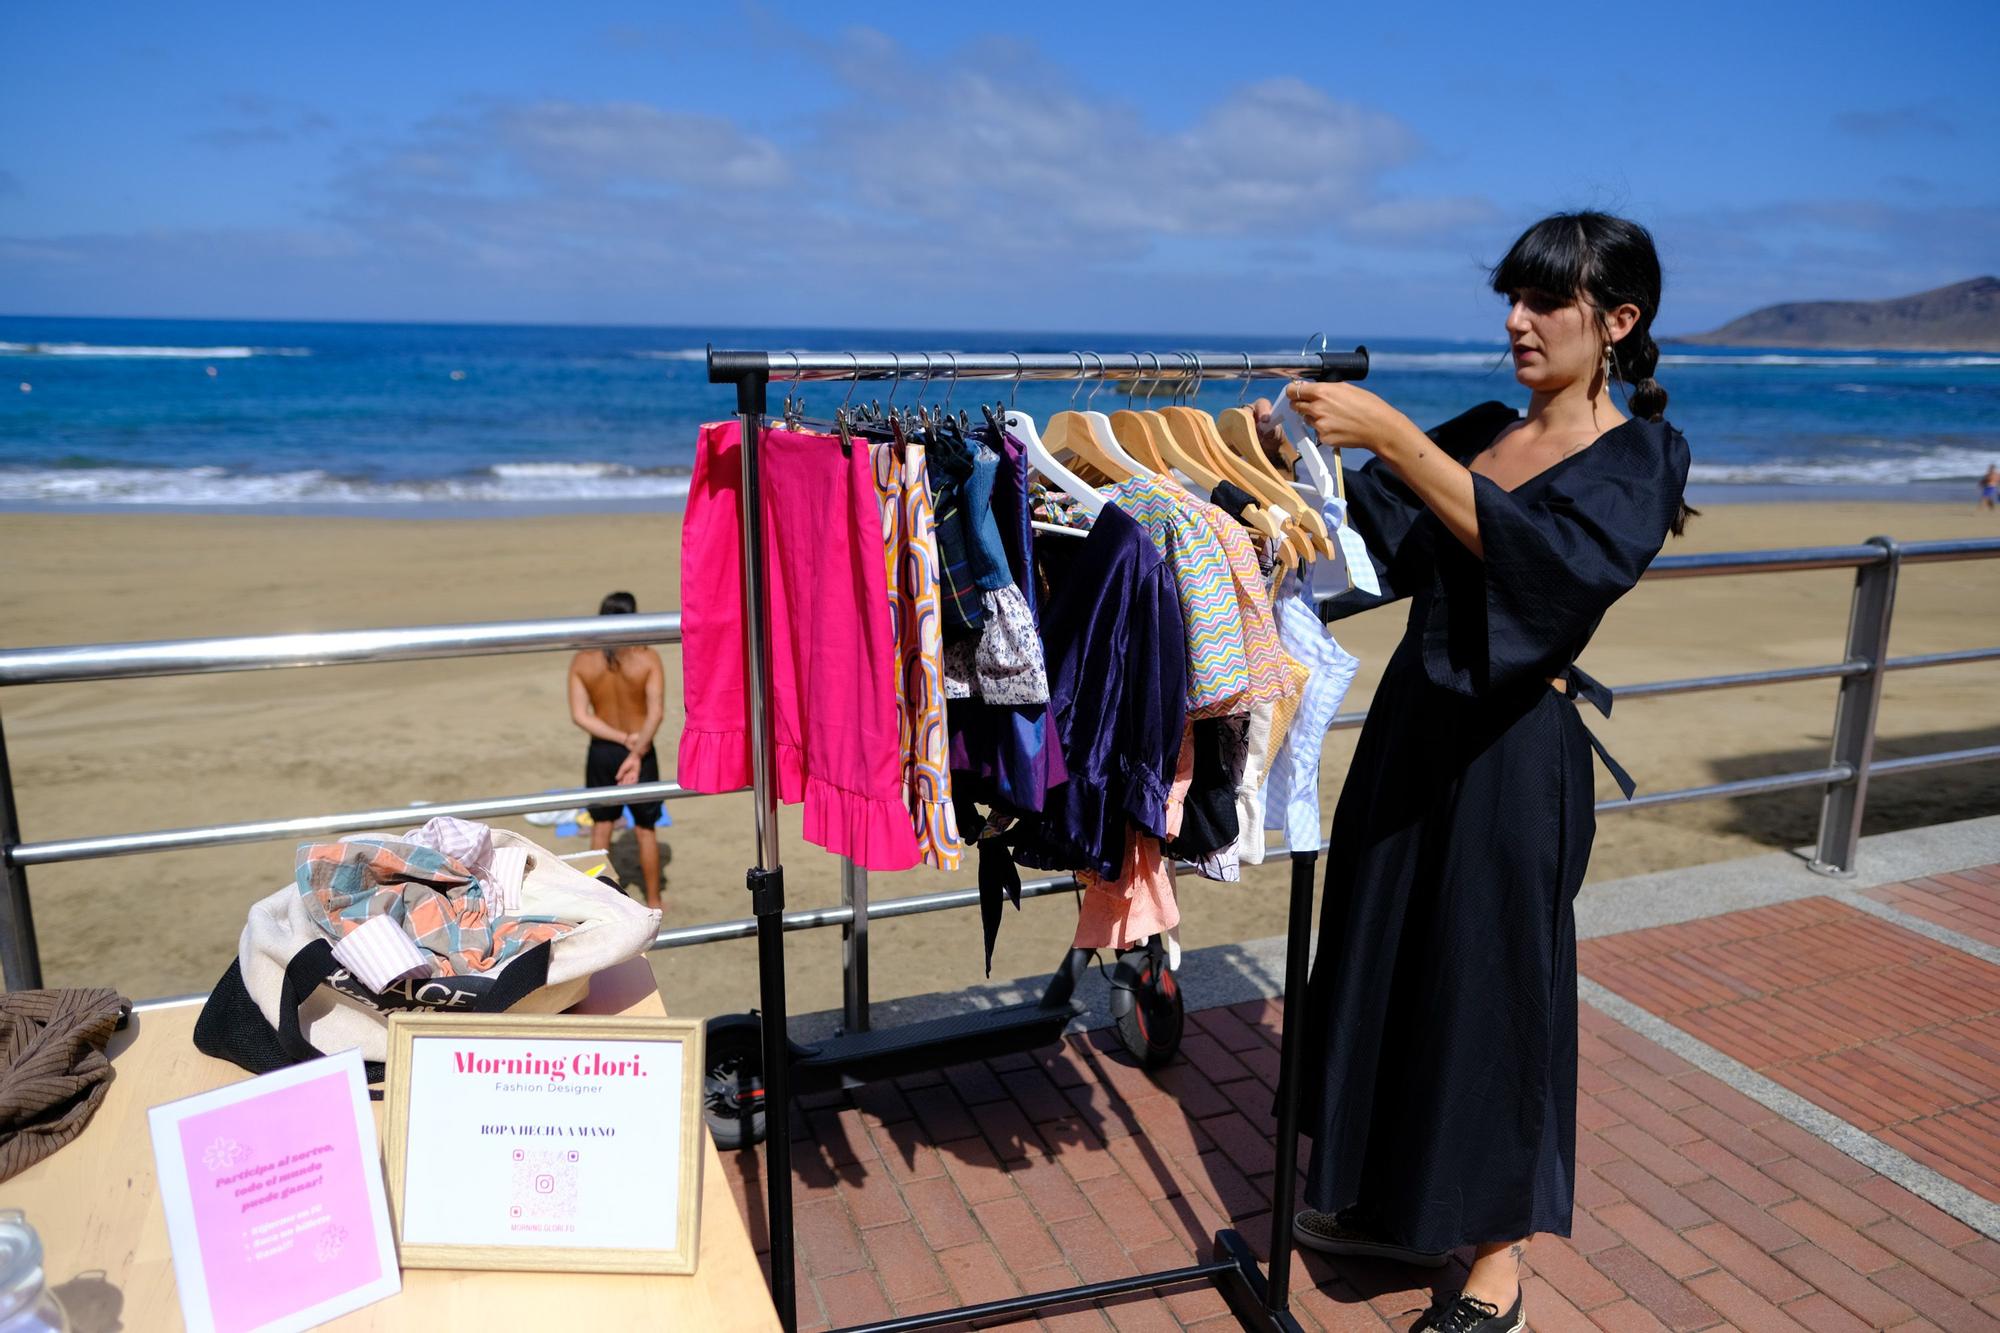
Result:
[570, 592, 664, 907]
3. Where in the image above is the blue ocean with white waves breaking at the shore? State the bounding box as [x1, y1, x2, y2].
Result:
[0, 316, 2000, 516]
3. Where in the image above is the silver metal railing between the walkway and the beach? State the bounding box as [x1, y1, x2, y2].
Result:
[0, 536, 2000, 996]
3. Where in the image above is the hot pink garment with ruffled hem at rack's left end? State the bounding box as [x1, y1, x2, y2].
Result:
[674, 420, 918, 871]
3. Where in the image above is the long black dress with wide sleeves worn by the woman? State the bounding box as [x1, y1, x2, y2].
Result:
[1300, 402, 1688, 1251]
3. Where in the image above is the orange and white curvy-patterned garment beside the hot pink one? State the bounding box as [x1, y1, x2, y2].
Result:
[868, 444, 964, 871]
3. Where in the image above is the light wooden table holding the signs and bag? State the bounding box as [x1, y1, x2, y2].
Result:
[0, 959, 778, 1333]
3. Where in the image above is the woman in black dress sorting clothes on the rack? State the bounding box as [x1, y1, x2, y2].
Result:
[1264, 212, 1692, 1333]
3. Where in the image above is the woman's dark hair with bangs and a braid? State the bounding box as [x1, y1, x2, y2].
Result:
[1490, 212, 1696, 536]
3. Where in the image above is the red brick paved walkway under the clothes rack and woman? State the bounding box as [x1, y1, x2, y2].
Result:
[724, 867, 2000, 1333]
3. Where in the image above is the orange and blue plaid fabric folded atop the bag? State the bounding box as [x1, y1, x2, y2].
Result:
[298, 839, 574, 977]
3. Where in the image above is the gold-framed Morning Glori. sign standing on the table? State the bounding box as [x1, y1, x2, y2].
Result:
[382, 1013, 706, 1275]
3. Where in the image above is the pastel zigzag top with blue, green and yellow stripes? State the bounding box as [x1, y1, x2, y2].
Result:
[1106, 476, 1250, 717]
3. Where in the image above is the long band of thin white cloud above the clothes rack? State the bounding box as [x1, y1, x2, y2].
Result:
[300, 30, 1482, 280]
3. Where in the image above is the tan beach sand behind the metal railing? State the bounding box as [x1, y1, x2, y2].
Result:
[0, 504, 2000, 1015]
